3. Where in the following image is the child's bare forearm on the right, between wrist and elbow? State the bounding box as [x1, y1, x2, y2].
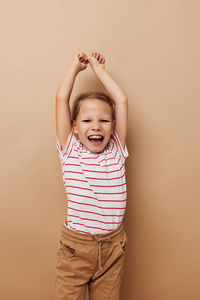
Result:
[95, 68, 128, 104]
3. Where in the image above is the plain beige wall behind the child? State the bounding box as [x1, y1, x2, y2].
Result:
[0, 0, 200, 300]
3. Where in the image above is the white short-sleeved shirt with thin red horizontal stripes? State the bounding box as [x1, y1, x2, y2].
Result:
[56, 131, 128, 234]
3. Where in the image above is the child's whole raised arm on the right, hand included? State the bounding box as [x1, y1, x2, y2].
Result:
[89, 52, 128, 148]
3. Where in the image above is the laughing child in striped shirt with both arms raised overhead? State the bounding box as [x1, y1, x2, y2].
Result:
[55, 52, 128, 300]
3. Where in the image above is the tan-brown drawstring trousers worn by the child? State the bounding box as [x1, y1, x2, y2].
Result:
[55, 223, 127, 300]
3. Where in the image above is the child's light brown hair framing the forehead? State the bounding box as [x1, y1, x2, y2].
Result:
[71, 91, 115, 120]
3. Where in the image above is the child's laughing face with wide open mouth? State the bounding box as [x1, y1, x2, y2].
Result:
[73, 99, 114, 153]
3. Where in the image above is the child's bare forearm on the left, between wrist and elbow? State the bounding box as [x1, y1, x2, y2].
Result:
[56, 65, 78, 102]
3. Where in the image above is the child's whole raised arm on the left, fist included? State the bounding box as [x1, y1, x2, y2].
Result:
[56, 52, 89, 150]
